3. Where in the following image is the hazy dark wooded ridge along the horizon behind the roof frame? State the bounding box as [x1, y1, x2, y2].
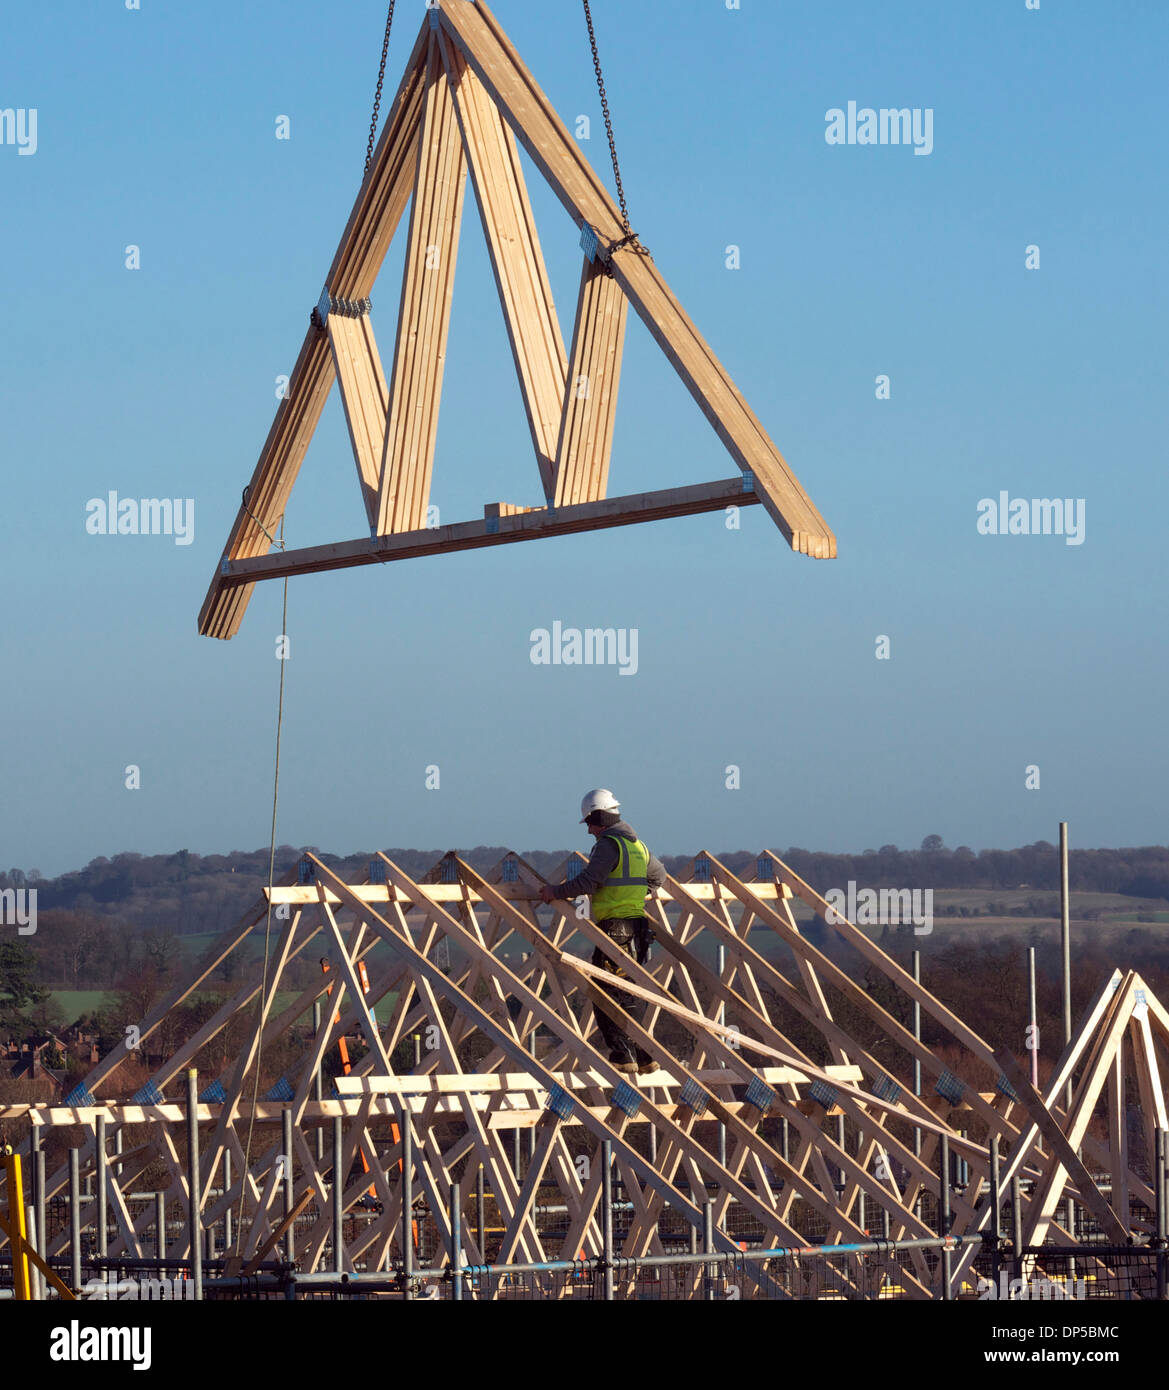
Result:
[0, 835, 1169, 934]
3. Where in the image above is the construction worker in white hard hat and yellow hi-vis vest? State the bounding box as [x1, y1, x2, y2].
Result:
[539, 787, 666, 1073]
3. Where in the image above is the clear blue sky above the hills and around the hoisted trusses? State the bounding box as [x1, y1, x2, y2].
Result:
[0, 0, 1169, 874]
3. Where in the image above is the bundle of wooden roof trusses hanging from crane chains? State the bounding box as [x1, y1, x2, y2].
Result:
[199, 0, 835, 638]
